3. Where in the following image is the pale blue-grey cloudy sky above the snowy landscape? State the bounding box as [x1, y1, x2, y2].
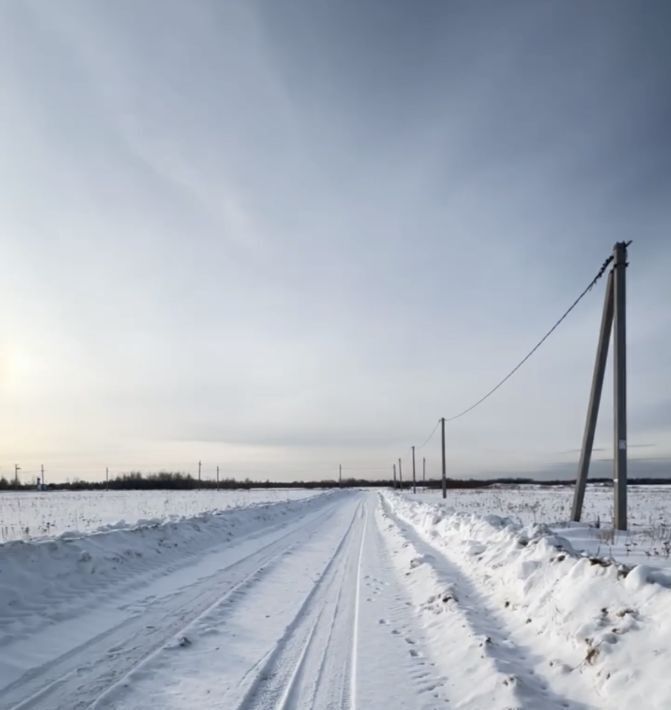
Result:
[0, 0, 671, 480]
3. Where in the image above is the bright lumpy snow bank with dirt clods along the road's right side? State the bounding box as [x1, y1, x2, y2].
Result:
[385, 493, 671, 708]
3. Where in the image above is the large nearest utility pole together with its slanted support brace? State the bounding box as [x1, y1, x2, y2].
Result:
[571, 242, 629, 530]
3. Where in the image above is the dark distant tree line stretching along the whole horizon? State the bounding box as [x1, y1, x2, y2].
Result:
[0, 471, 671, 491]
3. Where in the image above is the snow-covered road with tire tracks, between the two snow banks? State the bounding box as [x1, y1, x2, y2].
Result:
[0, 492, 442, 709]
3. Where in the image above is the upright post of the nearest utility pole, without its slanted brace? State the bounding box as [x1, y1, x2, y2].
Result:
[613, 242, 627, 530]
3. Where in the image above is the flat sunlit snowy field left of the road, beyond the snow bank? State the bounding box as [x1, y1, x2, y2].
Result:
[0, 488, 316, 542]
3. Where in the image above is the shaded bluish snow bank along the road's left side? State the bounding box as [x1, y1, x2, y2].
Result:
[0, 492, 333, 648]
